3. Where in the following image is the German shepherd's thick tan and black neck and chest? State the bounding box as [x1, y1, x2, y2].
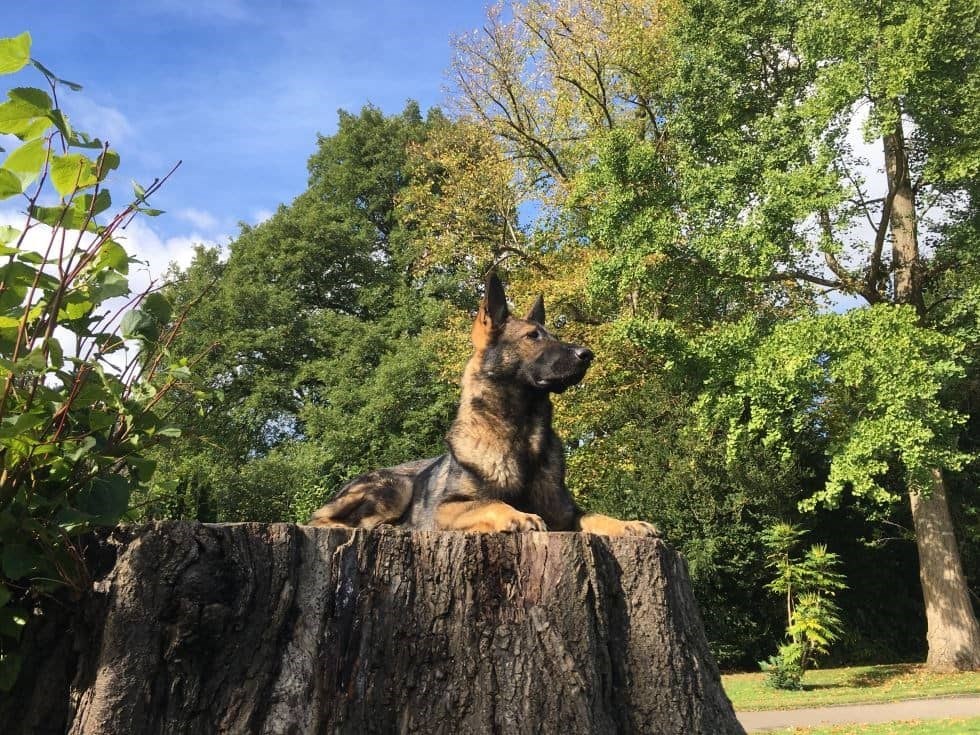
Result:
[446, 355, 557, 497]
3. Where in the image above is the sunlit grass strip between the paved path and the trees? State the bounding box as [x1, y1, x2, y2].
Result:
[722, 664, 980, 712]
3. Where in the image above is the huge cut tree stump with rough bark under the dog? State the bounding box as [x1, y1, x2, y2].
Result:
[0, 522, 742, 735]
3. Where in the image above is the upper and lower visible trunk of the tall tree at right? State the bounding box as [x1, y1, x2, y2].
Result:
[884, 107, 980, 671]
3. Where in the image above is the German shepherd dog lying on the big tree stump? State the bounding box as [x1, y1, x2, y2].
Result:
[310, 274, 657, 536]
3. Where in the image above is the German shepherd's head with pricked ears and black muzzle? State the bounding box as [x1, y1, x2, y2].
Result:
[473, 274, 594, 393]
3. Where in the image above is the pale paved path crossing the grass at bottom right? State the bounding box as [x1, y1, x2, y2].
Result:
[736, 697, 980, 732]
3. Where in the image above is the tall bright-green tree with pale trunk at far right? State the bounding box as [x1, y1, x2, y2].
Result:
[677, 0, 980, 669]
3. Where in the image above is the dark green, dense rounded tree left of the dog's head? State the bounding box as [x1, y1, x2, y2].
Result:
[148, 103, 453, 520]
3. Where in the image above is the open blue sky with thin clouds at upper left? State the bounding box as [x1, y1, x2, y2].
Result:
[0, 0, 485, 278]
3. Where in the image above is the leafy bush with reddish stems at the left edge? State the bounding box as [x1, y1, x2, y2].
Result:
[0, 33, 187, 690]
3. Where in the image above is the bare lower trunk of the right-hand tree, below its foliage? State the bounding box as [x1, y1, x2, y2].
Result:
[910, 470, 980, 671]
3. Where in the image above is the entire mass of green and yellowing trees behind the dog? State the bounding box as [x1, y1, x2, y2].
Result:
[147, 0, 980, 668]
